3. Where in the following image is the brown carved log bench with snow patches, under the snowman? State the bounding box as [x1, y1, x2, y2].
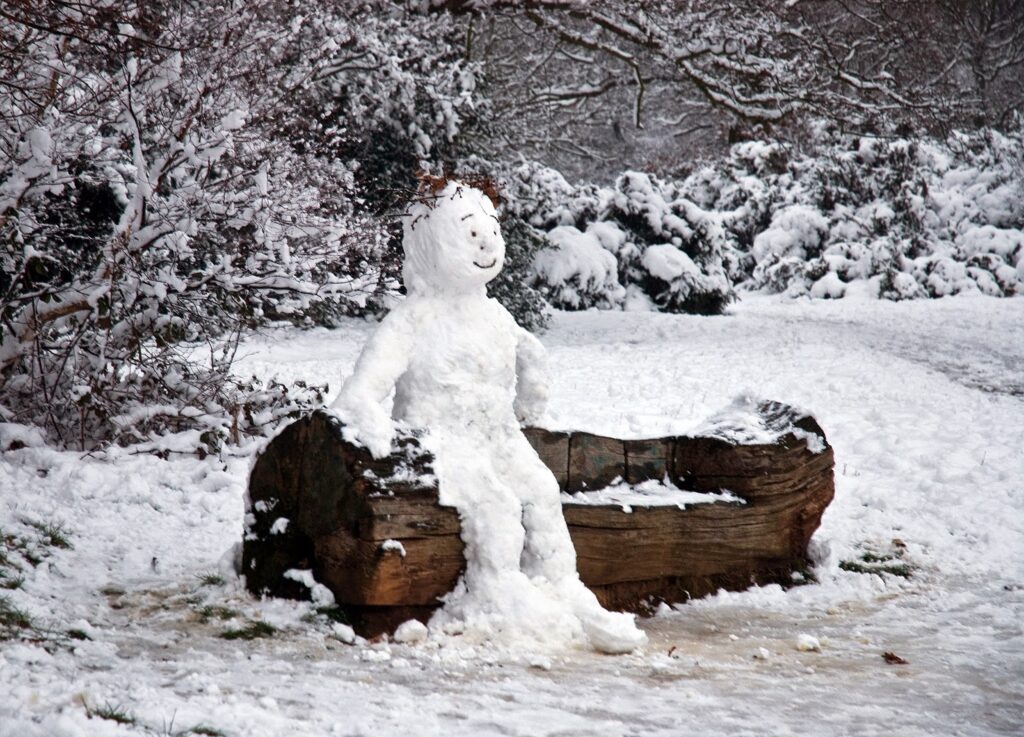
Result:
[243, 402, 835, 636]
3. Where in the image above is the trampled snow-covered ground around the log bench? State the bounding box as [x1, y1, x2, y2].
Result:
[0, 297, 1024, 737]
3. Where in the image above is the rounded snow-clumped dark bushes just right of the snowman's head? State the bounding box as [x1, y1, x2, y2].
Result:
[512, 165, 732, 314]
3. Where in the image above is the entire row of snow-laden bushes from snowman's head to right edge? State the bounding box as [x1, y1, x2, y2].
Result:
[511, 130, 1024, 313]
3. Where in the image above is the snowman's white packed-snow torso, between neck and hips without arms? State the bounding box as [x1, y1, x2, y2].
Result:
[392, 295, 518, 435]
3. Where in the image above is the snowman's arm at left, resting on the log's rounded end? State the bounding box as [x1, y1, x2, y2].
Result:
[331, 310, 412, 458]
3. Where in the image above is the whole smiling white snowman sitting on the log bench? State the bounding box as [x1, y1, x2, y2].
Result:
[334, 181, 646, 652]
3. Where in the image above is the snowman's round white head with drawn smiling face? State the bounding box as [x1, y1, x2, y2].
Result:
[402, 179, 505, 296]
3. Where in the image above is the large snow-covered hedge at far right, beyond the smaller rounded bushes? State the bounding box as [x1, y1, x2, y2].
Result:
[726, 131, 1024, 299]
